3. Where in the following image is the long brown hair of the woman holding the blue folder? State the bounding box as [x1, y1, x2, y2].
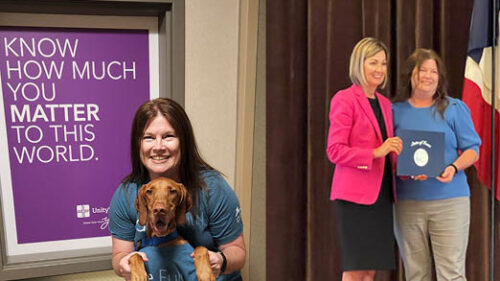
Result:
[394, 48, 449, 119]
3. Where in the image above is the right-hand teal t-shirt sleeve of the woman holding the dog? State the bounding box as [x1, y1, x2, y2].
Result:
[205, 172, 243, 245]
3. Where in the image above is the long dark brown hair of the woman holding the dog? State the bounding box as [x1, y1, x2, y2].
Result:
[122, 98, 215, 214]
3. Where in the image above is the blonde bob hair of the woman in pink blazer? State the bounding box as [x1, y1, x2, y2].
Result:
[349, 37, 389, 88]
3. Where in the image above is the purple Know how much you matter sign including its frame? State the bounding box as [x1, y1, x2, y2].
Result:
[0, 1, 184, 280]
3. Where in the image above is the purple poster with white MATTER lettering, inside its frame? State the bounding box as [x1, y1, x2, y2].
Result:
[0, 27, 150, 244]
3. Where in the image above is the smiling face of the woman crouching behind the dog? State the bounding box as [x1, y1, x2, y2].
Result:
[140, 114, 181, 181]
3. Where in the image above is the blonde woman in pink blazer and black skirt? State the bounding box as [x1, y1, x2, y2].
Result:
[327, 38, 402, 281]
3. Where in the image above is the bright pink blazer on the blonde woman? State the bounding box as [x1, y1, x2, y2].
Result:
[326, 85, 396, 205]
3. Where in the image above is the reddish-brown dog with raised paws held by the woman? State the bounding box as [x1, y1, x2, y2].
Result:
[129, 177, 215, 281]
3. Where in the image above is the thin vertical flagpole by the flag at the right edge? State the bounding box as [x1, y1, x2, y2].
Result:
[490, 0, 498, 281]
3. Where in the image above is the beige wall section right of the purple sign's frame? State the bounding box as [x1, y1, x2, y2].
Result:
[185, 0, 239, 187]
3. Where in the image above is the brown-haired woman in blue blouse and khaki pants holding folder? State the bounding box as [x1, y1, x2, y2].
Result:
[393, 49, 481, 281]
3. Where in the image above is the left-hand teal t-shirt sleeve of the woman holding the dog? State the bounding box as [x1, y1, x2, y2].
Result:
[109, 184, 137, 241]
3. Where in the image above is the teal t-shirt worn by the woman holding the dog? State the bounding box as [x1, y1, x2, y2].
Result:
[109, 170, 243, 281]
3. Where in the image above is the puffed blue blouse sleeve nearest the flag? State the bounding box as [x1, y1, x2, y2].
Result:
[449, 99, 481, 155]
